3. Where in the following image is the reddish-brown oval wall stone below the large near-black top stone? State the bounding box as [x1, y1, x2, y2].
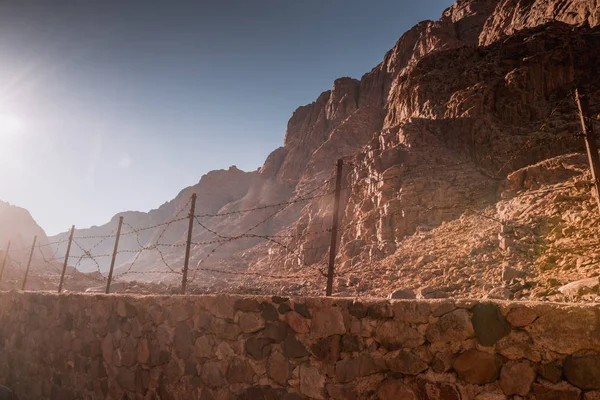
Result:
[453, 349, 502, 385]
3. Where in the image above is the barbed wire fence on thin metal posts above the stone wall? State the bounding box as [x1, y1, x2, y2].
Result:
[0, 87, 596, 295]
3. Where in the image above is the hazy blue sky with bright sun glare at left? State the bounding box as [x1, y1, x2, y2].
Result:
[0, 0, 452, 234]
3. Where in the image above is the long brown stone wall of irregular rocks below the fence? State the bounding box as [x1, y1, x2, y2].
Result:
[0, 292, 600, 400]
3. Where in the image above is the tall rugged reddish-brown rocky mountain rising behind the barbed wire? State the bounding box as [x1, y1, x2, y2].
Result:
[37, 0, 600, 295]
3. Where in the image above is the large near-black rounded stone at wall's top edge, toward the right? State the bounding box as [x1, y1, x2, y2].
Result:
[471, 303, 511, 346]
